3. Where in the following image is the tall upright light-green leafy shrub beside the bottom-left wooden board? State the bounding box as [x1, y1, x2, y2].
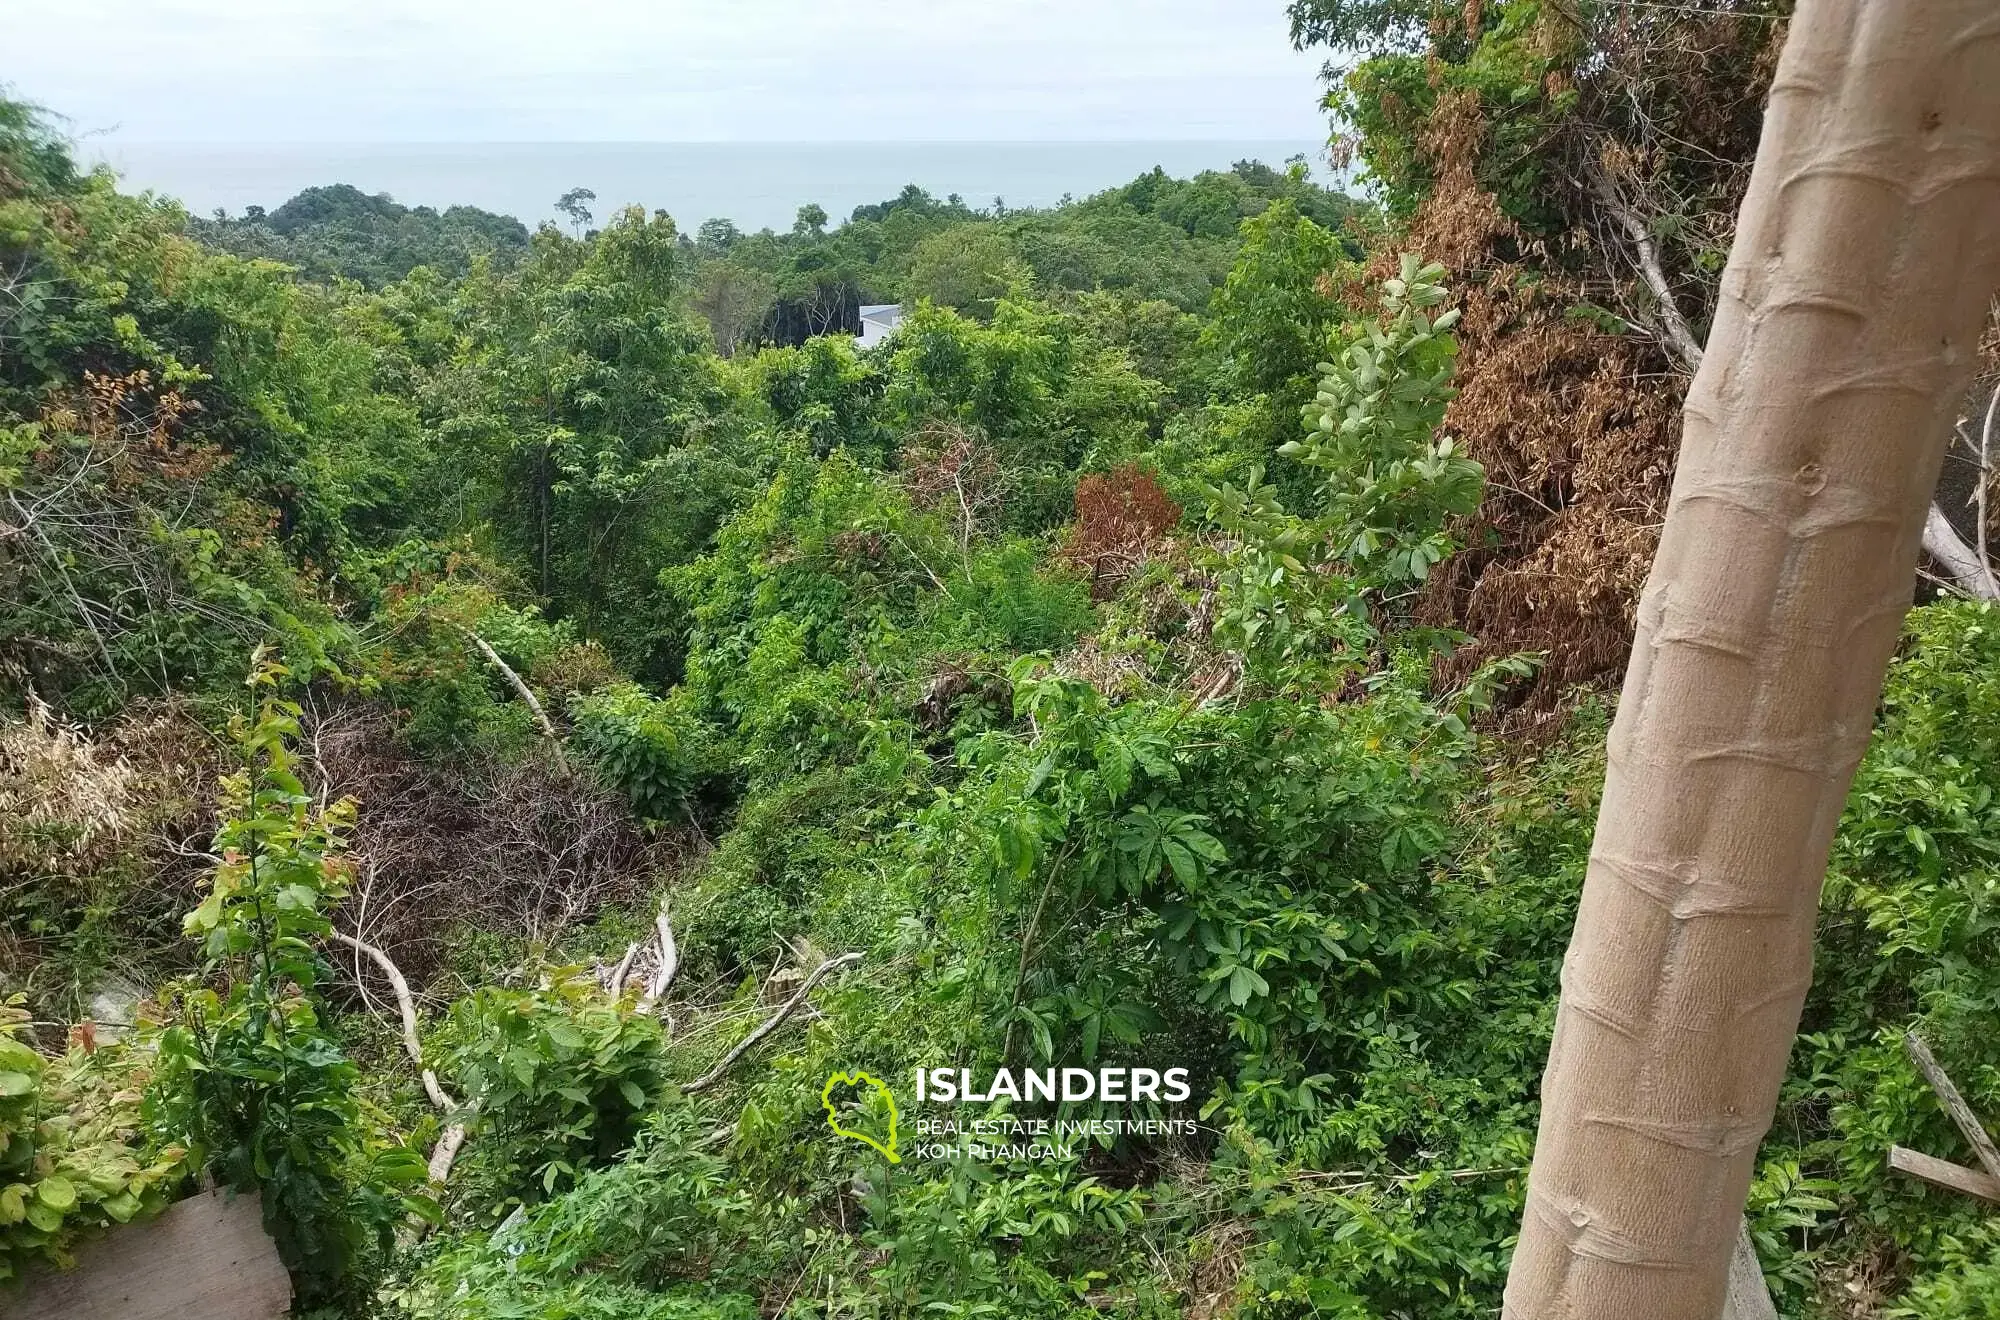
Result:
[148, 662, 436, 1302]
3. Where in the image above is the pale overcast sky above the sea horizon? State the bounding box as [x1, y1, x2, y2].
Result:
[0, 0, 1326, 142]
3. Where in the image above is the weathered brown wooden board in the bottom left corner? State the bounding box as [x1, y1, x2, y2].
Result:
[12, 1192, 292, 1320]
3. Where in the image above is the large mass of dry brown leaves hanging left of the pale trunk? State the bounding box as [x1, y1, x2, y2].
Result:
[1370, 94, 1682, 710]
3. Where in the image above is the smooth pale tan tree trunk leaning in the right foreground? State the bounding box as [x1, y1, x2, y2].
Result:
[1504, 0, 2000, 1320]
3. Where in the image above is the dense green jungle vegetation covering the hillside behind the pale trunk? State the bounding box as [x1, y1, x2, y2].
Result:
[0, 0, 2000, 1320]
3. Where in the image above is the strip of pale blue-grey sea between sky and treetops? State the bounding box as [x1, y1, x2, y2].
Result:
[82, 140, 1328, 230]
